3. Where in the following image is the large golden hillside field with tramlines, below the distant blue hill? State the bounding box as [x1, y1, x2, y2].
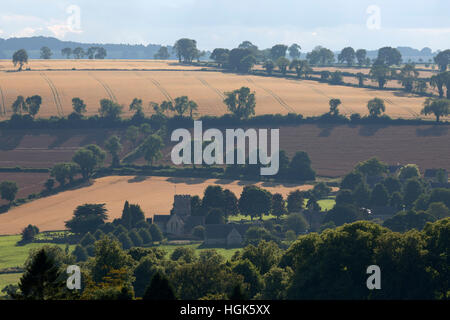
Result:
[0, 60, 432, 119]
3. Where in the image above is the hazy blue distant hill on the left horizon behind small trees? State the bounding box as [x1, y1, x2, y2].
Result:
[0, 37, 175, 59]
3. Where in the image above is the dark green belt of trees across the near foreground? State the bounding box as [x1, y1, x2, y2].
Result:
[8, 218, 450, 300]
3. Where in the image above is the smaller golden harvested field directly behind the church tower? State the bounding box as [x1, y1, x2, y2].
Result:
[0, 176, 318, 234]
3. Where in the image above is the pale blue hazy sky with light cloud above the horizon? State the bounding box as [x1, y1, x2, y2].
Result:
[0, 0, 450, 51]
